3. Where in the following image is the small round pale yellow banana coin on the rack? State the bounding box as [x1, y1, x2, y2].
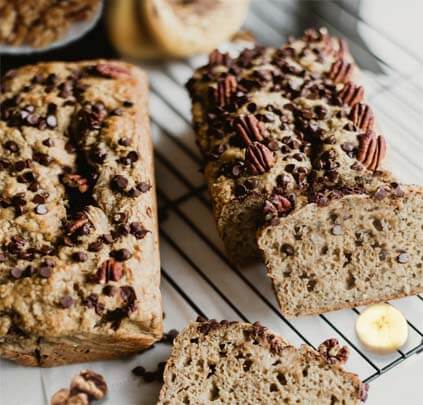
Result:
[355, 304, 408, 354]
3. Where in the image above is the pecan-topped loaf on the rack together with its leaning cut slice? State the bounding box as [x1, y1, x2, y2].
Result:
[187, 29, 423, 315]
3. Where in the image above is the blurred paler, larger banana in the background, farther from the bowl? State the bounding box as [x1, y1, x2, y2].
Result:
[141, 0, 249, 57]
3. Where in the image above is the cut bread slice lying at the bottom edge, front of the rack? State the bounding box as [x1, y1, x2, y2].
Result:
[159, 320, 368, 405]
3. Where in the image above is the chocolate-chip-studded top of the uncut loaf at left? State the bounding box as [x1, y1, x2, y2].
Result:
[0, 61, 162, 352]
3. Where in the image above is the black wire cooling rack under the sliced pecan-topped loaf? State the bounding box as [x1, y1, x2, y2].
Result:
[149, 0, 423, 382]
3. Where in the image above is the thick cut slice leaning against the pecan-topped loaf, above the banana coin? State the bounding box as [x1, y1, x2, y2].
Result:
[258, 186, 423, 316]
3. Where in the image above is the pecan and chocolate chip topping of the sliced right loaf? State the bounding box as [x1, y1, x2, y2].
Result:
[187, 29, 401, 222]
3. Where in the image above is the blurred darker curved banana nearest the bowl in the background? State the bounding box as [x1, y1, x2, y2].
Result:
[106, 0, 165, 59]
